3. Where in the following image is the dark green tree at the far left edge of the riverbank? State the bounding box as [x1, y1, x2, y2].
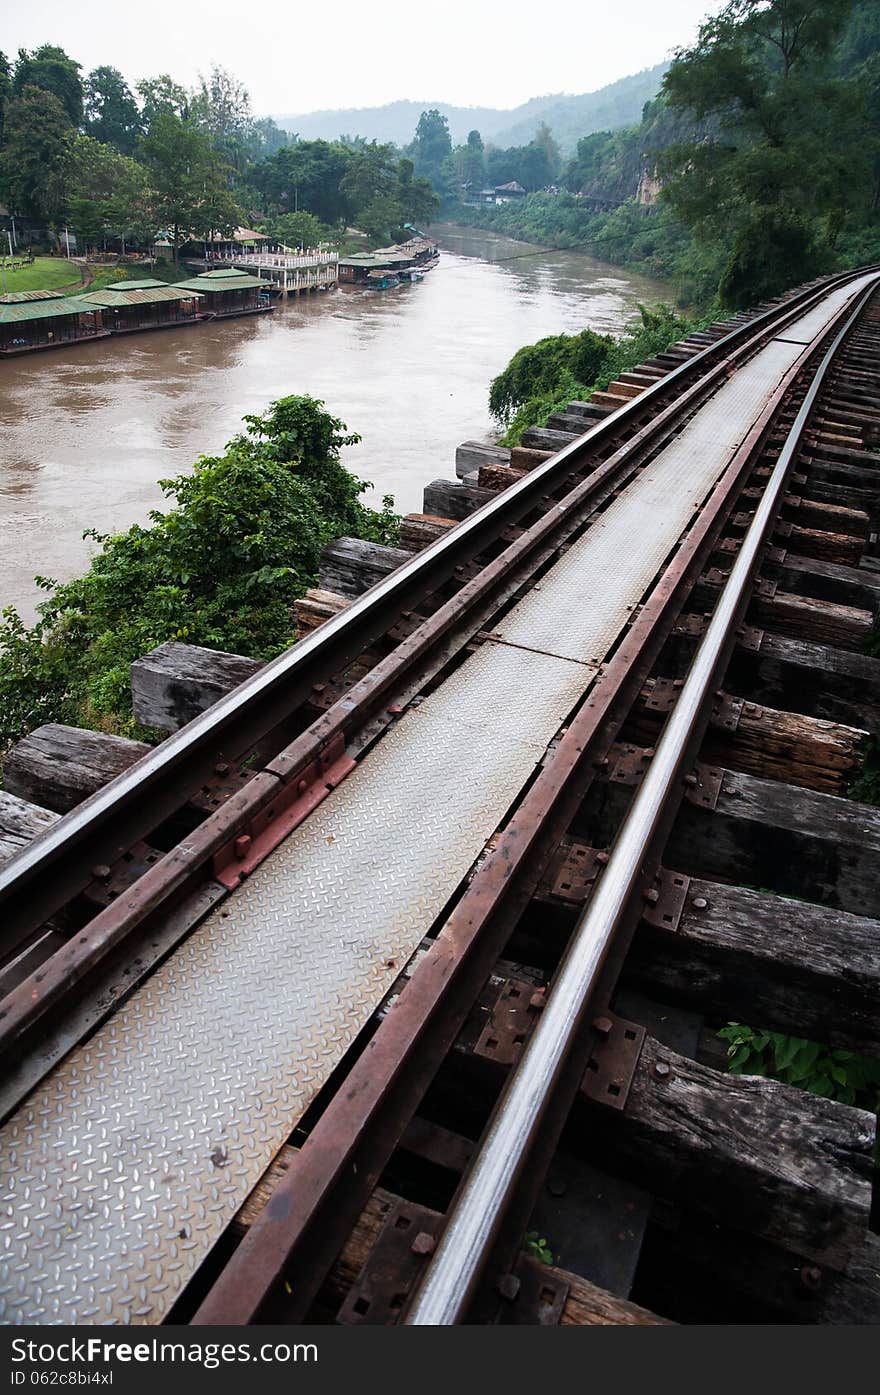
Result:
[0, 86, 71, 218]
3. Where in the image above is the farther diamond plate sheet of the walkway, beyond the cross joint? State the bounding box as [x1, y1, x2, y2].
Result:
[495, 342, 801, 663]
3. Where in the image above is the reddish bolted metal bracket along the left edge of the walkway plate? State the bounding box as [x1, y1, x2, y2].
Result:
[213, 732, 356, 891]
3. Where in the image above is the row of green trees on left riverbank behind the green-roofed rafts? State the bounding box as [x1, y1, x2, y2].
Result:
[0, 45, 438, 252]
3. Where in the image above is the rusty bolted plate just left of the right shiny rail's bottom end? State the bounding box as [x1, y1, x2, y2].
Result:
[336, 1201, 443, 1327]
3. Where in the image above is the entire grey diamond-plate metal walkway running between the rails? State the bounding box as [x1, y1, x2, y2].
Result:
[0, 277, 859, 1324]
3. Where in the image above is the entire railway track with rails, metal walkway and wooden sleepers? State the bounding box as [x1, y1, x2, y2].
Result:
[0, 272, 880, 1325]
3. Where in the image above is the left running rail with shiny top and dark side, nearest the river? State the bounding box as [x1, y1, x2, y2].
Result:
[0, 269, 865, 918]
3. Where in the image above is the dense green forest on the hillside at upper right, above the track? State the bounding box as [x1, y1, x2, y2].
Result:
[460, 0, 880, 308]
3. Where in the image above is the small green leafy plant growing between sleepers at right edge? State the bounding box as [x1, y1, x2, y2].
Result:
[718, 1023, 880, 1112]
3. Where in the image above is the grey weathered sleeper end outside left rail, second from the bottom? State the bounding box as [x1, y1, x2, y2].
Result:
[3, 721, 151, 813]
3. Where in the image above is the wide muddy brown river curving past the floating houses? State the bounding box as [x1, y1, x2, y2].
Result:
[0, 227, 664, 621]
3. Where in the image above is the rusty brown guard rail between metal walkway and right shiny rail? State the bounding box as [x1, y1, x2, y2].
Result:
[192, 274, 875, 1324]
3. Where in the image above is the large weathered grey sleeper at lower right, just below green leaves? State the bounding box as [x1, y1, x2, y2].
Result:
[583, 1036, 877, 1269]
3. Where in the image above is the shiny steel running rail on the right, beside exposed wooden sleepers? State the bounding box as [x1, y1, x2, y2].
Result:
[403, 266, 877, 1327]
